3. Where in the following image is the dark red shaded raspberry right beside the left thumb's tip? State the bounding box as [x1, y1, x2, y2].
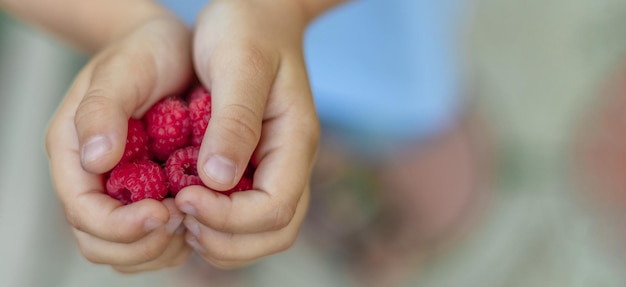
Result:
[120, 118, 152, 163]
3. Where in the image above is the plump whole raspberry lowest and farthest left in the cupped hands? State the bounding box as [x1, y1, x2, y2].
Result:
[106, 160, 168, 204]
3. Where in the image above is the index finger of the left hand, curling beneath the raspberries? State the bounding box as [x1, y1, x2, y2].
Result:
[46, 73, 169, 242]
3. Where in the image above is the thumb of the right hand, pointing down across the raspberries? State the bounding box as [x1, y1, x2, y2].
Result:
[195, 39, 278, 190]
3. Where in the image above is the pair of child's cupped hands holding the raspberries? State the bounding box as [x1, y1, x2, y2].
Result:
[46, 0, 319, 272]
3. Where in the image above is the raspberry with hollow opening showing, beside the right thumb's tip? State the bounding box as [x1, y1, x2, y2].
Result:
[165, 146, 203, 196]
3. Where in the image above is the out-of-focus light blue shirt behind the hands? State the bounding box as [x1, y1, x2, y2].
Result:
[161, 0, 464, 152]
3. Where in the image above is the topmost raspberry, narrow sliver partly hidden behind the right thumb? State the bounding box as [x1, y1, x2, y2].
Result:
[189, 86, 211, 146]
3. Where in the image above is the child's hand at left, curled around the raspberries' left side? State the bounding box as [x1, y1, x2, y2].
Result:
[46, 16, 193, 272]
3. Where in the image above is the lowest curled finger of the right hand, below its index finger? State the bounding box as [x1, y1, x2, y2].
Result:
[184, 190, 309, 268]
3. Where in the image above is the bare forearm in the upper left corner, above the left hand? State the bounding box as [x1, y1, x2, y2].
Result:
[0, 0, 168, 53]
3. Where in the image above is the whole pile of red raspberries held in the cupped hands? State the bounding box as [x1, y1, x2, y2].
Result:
[105, 86, 254, 204]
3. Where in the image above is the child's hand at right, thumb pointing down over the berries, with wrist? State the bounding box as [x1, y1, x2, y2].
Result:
[176, 0, 319, 268]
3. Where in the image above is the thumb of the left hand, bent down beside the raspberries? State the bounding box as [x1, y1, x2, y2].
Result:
[74, 25, 191, 173]
